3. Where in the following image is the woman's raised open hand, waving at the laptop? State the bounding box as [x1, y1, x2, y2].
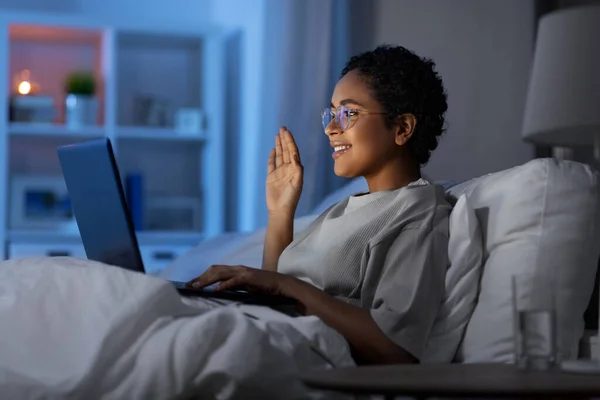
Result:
[266, 127, 304, 218]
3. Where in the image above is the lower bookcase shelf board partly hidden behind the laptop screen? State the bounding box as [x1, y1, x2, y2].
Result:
[8, 229, 204, 246]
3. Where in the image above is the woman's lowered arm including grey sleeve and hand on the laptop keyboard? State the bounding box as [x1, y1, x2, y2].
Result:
[188, 225, 448, 364]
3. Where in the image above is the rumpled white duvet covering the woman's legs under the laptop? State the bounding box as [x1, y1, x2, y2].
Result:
[0, 258, 353, 400]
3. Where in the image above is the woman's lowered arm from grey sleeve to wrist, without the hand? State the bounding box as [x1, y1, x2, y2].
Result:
[282, 225, 448, 364]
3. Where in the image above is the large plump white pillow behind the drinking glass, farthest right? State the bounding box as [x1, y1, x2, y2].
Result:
[450, 159, 600, 363]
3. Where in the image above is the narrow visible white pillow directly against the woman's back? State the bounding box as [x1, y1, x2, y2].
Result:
[421, 195, 483, 363]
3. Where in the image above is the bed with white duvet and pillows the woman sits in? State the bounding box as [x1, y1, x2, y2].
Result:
[0, 160, 600, 399]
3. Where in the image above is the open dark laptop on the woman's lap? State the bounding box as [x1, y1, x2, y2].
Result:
[57, 138, 296, 307]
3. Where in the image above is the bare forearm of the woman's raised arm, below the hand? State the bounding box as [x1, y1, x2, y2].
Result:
[262, 213, 294, 271]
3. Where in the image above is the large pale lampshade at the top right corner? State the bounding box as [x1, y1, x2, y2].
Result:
[523, 6, 600, 146]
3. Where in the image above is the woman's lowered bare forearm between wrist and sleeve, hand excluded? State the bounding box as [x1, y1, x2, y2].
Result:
[281, 277, 417, 364]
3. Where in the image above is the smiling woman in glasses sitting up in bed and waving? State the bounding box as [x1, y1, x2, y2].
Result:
[188, 46, 451, 364]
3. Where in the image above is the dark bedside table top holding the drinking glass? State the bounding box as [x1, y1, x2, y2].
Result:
[300, 364, 600, 399]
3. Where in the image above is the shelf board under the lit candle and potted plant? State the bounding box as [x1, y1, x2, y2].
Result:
[8, 122, 105, 139]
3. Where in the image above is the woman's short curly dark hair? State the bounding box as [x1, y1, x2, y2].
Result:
[341, 45, 448, 165]
